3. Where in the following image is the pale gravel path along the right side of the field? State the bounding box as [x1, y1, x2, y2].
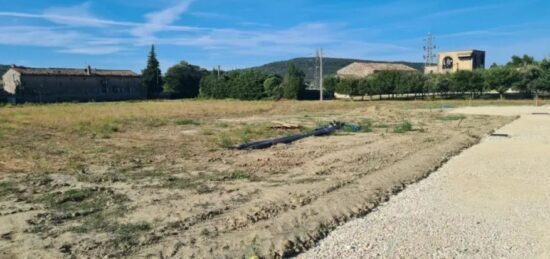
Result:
[298, 106, 550, 258]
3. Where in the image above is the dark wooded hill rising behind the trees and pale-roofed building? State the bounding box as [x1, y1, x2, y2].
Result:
[252, 58, 424, 81]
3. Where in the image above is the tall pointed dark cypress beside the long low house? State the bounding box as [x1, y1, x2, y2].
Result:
[141, 45, 163, 98]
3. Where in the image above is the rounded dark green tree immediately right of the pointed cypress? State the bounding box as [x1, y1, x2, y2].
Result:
[164, 61, 207, 98]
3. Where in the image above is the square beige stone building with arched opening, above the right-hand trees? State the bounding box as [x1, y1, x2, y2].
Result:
[424, 50, 485, 74]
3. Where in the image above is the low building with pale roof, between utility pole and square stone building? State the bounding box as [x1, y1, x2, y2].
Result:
[336, 62, 417, 78]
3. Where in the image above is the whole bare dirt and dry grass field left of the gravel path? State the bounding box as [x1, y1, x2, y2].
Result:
[0, 101, 528, 258]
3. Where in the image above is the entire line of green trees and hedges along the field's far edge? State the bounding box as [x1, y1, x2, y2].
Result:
[142, 46, 550, 100]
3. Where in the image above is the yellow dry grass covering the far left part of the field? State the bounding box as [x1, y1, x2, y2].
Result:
[0, 100, 549, 175]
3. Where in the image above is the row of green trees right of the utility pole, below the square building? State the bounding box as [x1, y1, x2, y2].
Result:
[324, 55, 550, 98]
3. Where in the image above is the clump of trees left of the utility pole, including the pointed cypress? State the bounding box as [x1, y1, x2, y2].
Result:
[142, 46, 306, 100]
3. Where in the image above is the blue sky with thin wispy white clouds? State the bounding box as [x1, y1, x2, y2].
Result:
[0, 0, 550, 71]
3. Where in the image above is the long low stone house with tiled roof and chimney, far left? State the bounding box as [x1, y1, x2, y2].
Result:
[2, 66, 146, 102]
